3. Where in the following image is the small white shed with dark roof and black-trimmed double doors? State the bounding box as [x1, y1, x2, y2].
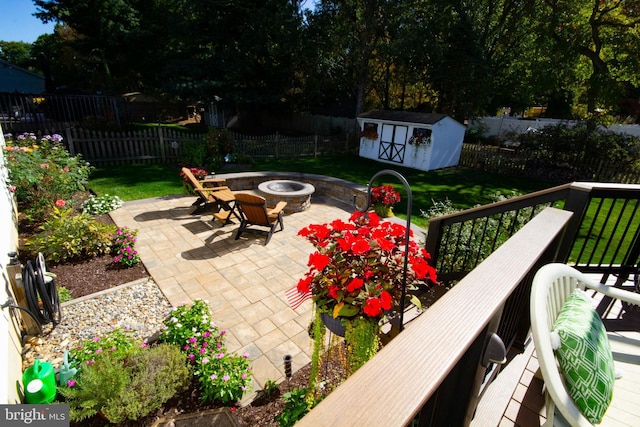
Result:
[357, 110, 466, 171]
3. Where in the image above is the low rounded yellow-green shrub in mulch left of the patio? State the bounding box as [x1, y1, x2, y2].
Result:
[25, 207, 116, 262]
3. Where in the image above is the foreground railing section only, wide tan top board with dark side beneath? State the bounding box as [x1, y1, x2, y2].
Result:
[297, 208, 573, 427]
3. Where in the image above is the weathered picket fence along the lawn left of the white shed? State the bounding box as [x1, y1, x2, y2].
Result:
[65, 127, 348, 165]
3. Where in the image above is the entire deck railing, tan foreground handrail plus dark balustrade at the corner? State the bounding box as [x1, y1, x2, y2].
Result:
[298, 183, 640, 427]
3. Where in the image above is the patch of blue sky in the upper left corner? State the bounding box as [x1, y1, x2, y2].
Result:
[0, 0, 54, 43]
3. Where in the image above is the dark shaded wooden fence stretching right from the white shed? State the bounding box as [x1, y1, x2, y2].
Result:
[459, 144, 640, 184]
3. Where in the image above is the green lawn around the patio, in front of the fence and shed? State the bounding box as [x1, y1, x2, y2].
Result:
[89, 155, 552, 226]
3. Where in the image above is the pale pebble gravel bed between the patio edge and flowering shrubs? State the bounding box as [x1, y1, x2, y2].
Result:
[22, 279, 171, 370]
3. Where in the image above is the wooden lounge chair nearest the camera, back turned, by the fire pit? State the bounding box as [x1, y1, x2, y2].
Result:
[235, 193, 287, 245]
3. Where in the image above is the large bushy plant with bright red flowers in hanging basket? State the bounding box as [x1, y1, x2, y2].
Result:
[298, 212, 437, 318]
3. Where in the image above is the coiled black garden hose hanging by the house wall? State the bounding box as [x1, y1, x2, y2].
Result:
[22, 254, 62, 327]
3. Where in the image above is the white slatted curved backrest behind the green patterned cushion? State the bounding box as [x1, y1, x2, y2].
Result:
[531, 264, 592, 426]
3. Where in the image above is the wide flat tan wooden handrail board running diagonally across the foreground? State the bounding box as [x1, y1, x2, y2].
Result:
[296, 208, 572, 427]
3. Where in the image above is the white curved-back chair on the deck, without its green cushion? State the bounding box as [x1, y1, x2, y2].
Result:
[531, 264, 640, 426]
